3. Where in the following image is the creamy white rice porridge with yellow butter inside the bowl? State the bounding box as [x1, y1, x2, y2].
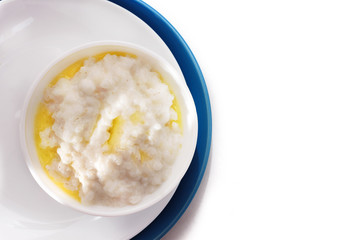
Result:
[34, 53, 182, 206]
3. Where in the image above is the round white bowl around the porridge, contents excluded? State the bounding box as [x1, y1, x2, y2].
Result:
[20, 41, 198, 216]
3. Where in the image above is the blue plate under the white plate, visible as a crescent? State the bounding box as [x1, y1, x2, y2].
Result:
[108, 0, 211, 240]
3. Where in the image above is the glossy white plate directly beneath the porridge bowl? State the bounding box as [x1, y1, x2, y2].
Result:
[0, 0, 181, 240]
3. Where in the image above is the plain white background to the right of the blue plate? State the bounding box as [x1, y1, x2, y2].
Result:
[146, 0, 360, 240]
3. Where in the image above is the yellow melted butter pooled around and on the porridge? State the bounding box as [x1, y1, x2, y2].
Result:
[34, 51, 183, 202]
